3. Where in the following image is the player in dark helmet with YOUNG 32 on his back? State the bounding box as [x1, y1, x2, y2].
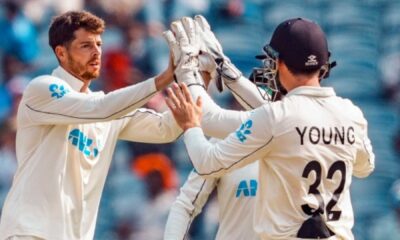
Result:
[163, 15, 375, 239]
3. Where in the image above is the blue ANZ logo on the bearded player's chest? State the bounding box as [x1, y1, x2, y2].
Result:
[68, 128, 99, 158]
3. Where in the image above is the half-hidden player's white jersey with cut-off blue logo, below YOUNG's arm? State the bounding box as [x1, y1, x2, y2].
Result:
[164, 162, 259, 240]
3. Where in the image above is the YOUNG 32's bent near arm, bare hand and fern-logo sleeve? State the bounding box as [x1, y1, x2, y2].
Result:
[167, 84, 273, 177]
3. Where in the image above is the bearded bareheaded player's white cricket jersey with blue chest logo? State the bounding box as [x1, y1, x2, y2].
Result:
[0, 67, 181, 240]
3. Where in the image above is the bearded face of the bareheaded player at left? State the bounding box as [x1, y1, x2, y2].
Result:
[59, 28, 102, 81]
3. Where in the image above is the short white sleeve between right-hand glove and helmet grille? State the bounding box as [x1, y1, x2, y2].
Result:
[225, 76, 268, 110]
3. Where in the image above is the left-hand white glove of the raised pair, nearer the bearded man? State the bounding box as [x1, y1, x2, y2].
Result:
[163, 17, 204, 86]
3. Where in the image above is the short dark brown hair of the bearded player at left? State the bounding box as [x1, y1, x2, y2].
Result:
[49, 11, 105, 51]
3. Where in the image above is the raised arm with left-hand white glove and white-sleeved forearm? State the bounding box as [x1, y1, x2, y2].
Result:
[164, 18, 247, 138]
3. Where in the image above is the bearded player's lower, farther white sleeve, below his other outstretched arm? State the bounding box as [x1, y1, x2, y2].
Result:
[119, 108, 182, 143]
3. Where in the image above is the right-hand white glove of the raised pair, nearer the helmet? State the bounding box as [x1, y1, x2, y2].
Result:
[194, 15, 242, 91]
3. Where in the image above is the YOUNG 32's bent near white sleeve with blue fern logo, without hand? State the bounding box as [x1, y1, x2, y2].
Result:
[184, 107, 273, 177]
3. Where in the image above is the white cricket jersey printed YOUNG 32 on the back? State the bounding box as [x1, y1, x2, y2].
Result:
[184, 86, 375, 240]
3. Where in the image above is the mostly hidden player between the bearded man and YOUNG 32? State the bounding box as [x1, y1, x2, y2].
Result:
[164, 17, 273, 240]
